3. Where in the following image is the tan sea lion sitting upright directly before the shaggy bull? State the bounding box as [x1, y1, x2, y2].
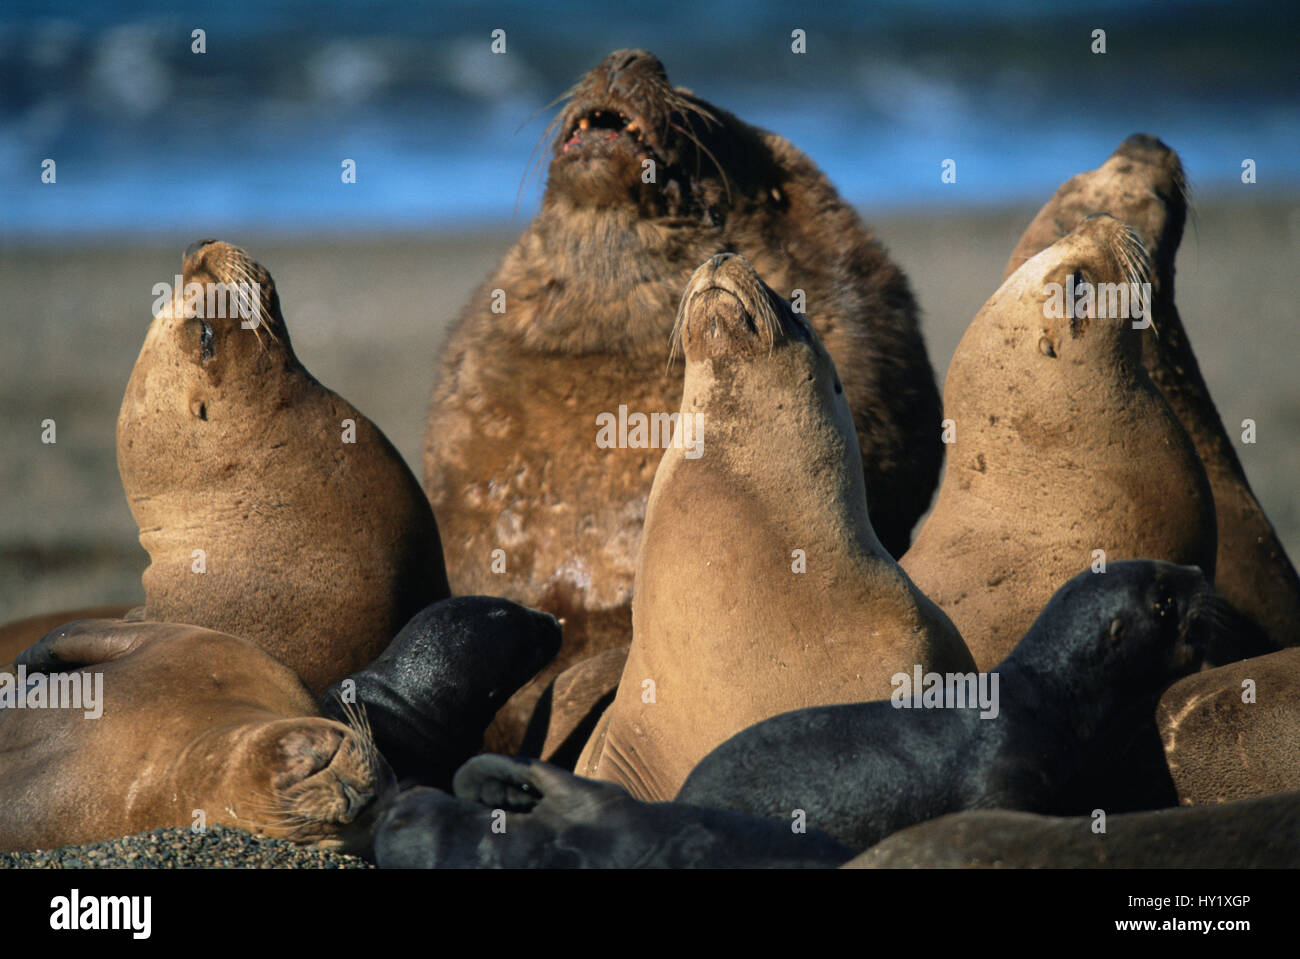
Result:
[577, 253, 974, 800]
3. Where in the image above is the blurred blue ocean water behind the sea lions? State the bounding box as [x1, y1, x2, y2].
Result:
[0, 0, 1300, 238]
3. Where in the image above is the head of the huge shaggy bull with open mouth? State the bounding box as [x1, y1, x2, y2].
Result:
[546, 49, 768, 224]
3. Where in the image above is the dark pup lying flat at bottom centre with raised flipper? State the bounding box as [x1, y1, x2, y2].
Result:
[373, 755, 853, 869]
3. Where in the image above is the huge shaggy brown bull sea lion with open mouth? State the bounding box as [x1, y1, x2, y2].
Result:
[424, 49, 943, 751]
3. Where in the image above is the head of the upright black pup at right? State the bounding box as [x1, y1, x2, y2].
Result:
[1009, 560, 1232, 706]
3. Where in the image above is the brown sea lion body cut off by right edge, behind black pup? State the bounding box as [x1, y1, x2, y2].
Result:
[1156, 648, 1300, 803]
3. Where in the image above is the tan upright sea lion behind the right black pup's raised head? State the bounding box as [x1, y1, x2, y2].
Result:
[901, 216, 1214, 669]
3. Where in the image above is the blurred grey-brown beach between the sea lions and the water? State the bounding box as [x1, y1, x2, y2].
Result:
[0, 197, 1300, 620]
